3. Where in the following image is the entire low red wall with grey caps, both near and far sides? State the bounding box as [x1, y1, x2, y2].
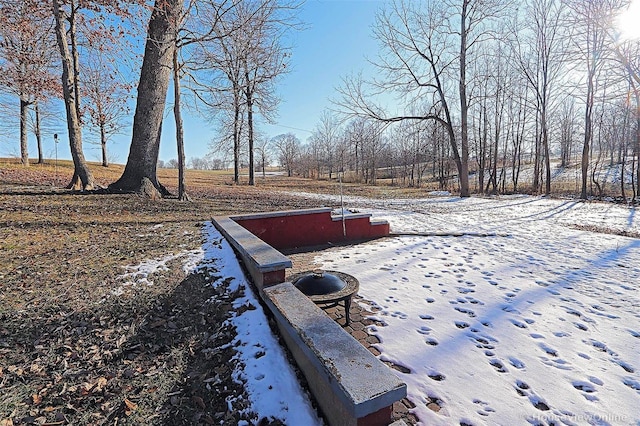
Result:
[213, 209, 407, 426]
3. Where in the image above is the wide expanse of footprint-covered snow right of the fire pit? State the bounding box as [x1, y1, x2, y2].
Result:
[300, 194, 640, 425]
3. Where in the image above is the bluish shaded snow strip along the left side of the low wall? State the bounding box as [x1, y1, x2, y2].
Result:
[112, 222, 322, 426]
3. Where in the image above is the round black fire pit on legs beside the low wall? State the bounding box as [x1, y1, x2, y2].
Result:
[289, 270, 359, 325]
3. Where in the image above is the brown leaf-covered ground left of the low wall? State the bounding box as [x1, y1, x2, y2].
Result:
[0, 161, 340, 426]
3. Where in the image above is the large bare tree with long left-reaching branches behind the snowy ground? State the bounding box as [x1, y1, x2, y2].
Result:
[338, 0, 504, 197]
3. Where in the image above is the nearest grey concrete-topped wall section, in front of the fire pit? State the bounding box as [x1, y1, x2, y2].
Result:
[264, 282, 407, 426]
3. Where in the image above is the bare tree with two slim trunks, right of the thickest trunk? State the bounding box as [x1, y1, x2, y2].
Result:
[201, 0, 299, 185]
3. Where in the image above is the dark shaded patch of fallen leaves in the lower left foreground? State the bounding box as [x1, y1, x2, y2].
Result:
[0, 269, 264, 425]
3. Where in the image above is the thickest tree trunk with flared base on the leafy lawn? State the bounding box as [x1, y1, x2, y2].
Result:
[109, 0, 184, 195]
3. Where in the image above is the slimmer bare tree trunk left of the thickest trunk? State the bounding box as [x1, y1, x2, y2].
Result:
[53, 0, 94, 190]
